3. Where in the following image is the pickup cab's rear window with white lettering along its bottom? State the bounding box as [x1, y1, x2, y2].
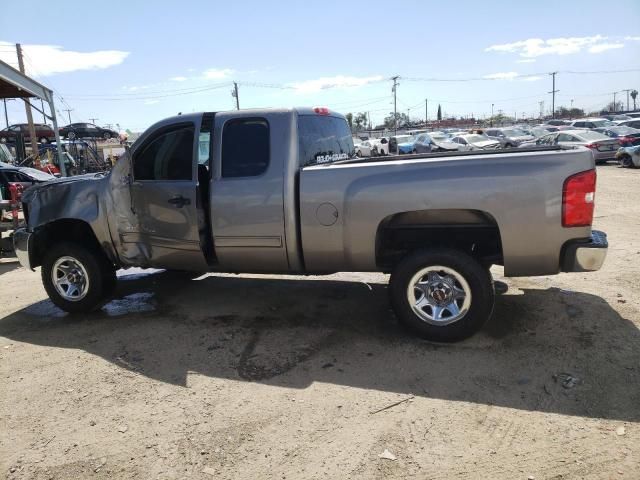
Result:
[298, 115, 355, 166]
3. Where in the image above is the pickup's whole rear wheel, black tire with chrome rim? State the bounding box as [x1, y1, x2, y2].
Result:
[389, 248, 495, 342]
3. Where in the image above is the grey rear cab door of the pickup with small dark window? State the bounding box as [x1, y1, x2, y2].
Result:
[211, 111, 296, 272]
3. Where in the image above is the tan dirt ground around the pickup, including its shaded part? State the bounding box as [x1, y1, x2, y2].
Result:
[0, 165, 640, 480]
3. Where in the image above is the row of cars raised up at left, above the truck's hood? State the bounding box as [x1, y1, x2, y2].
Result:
[0, 123, 119, 143]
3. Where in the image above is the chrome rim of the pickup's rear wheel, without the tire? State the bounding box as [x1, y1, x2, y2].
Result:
[407, 265, 471, 325]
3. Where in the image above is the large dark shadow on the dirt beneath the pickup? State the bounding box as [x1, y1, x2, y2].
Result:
[0, 272, 640, 421]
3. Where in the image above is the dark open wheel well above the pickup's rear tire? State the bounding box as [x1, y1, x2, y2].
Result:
[375, 209, 504, 271]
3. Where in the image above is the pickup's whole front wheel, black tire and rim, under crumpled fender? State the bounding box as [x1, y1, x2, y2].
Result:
[42, 242, 116, 313]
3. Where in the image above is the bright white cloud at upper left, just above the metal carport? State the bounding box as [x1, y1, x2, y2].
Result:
[0, 41, 129, 77]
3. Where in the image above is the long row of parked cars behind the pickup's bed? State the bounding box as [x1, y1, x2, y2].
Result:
[354, 118, 640, 166]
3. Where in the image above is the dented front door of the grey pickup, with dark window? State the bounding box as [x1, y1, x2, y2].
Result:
[123, 122, 208, 271]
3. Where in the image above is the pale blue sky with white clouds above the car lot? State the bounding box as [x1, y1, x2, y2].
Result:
[0, 0, 640, 131]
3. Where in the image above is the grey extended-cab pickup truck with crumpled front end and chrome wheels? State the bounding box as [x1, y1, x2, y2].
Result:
[14, 108, 607, 341]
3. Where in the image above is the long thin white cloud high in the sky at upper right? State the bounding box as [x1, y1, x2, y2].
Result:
[485, 35, 624, 58]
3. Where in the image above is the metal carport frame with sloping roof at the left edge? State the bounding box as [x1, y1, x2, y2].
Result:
[0, 60, 67, 177]
